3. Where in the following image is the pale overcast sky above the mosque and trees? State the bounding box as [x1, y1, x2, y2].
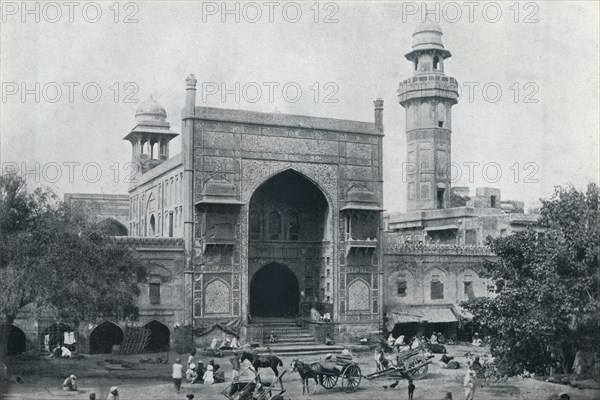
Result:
[0, 1, 600, 211]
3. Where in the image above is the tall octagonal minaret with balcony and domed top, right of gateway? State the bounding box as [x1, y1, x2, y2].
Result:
[398, 20, 458, 211]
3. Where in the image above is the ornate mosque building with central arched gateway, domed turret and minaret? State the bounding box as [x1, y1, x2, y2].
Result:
[5, 21, 537, 352]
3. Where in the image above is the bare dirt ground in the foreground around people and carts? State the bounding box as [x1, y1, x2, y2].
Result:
[5, 346, 600, 400]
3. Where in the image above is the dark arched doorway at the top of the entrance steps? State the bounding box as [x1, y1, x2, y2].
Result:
[250, 263, 300, 318]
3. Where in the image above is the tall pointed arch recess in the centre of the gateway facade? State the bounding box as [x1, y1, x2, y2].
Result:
[248, 170, 331, 318]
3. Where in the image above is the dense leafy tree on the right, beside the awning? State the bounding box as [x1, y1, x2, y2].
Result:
[461, 184, 600, 375]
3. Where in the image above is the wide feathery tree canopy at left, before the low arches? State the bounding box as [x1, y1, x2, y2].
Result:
[0, 175, 145, 321]
